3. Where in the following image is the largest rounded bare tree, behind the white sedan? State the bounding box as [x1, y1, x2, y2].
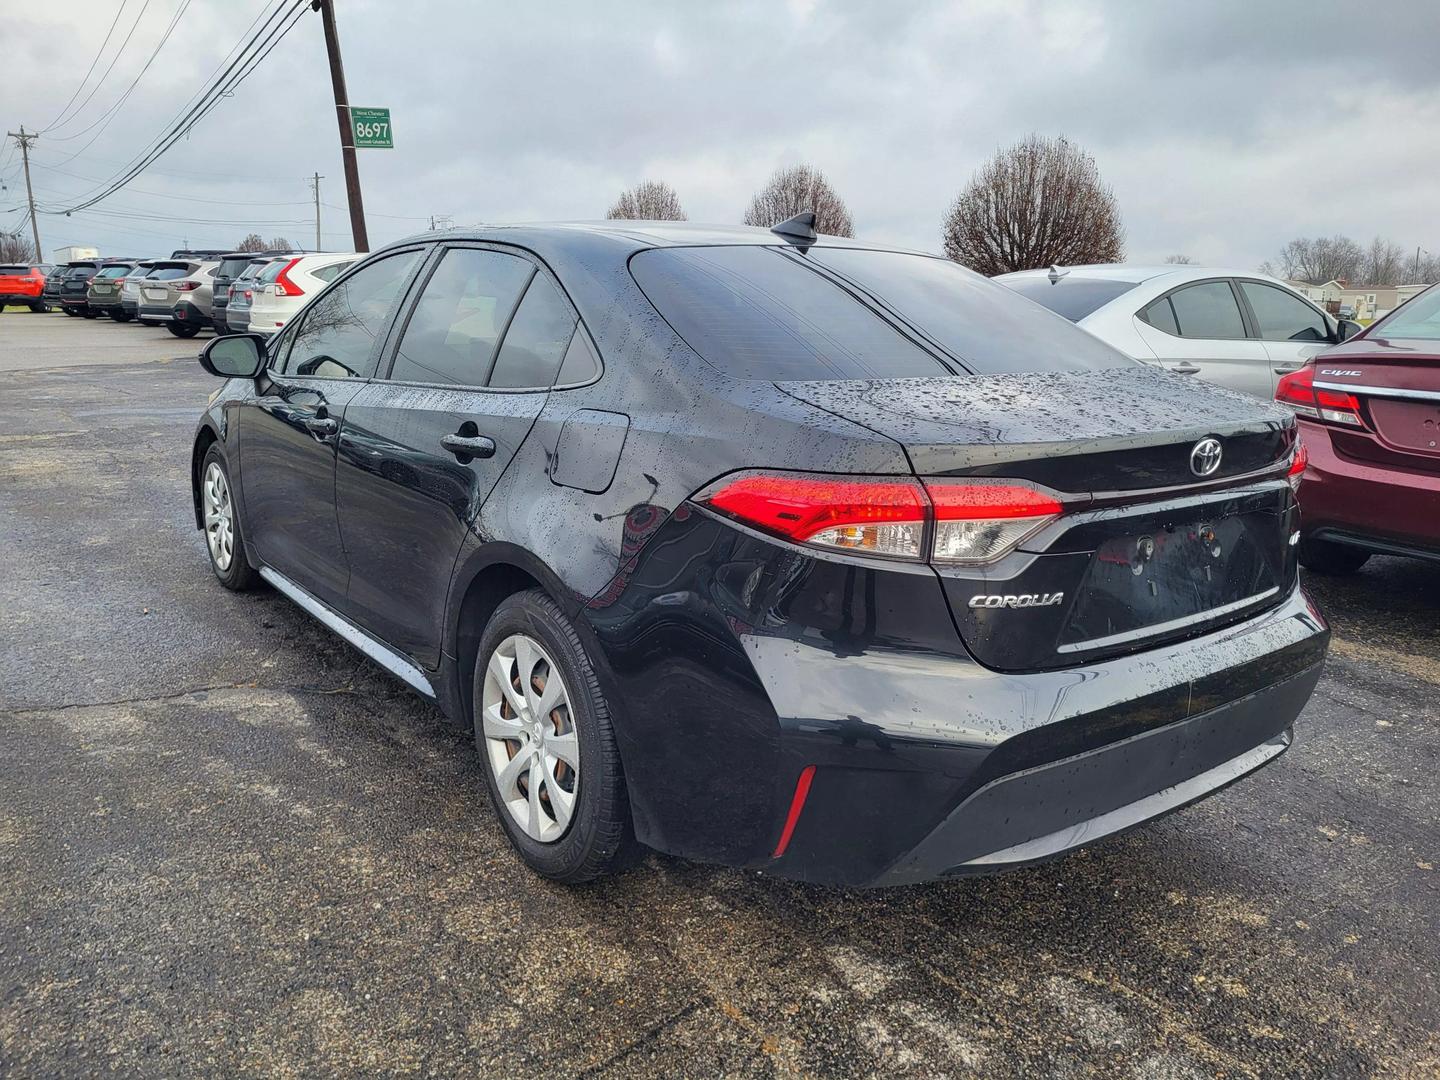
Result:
[943, 134, 1125, 275]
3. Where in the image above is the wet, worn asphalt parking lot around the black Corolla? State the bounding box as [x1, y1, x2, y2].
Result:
[0, 311, 1440, 1080]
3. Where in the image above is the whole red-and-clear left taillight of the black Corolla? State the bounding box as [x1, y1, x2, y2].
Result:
[697, 472, 1063, 564]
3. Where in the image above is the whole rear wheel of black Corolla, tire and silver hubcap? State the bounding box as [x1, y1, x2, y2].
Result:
[471, 589, 642, 884]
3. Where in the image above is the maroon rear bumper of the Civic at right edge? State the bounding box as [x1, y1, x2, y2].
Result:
[1300, 420, 1440, 559]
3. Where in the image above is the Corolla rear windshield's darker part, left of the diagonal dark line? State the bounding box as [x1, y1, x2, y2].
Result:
[629, 246, 944, 380]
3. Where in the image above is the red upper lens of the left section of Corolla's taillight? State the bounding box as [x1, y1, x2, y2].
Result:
[703, 474, 924, 541]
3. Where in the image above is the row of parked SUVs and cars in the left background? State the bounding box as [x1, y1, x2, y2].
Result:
[16, 251, 359, 337]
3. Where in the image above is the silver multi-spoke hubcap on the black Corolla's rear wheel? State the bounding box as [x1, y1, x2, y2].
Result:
[480, 634, 580, 844]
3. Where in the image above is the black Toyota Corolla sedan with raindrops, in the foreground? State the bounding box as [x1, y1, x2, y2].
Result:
[192, 215, 1329, 884]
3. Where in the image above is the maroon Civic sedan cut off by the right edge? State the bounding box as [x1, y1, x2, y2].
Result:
[1274, 285, 1440, 573]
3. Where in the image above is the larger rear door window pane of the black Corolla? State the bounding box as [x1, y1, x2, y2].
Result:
[388, 248, 534, 386]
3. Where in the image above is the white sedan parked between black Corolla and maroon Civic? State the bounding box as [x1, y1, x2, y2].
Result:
[995, 264, 1359, 397]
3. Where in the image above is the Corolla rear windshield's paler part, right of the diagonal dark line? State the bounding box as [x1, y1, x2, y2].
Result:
[808, 248, 1135, 374]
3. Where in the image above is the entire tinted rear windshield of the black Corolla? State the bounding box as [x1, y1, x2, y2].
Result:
[631, 248, 1133, 380]
